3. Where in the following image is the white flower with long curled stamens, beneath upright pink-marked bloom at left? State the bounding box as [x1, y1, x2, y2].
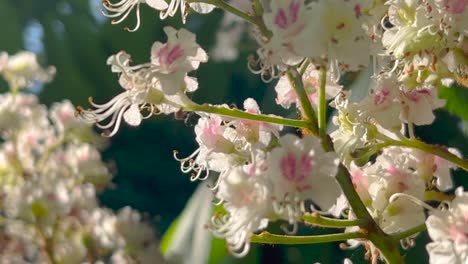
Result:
[77, 48, 199, 137]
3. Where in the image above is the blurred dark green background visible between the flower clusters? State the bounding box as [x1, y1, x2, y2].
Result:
[0, 0, 468, 264]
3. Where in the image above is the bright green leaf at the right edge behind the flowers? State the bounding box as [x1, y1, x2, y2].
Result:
[439, 85, 468, 121]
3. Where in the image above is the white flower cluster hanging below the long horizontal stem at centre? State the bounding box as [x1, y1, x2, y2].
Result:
[176, 102, 341, 256]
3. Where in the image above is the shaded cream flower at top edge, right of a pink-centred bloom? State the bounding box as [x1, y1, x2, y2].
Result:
[298, 0, 370, 71]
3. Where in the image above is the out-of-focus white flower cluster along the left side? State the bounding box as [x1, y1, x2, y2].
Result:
[0, 52, 163, 264]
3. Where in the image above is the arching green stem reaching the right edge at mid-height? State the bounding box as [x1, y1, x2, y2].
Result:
[382, 139, 468, 171]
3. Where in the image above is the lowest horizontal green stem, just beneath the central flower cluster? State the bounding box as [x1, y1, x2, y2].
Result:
[250, 232, 366, 245]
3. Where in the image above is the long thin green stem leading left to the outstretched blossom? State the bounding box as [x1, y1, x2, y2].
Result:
[182, 104, 310, 128]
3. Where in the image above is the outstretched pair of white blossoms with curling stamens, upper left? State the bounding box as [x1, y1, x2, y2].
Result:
[77, 27, 208, 136]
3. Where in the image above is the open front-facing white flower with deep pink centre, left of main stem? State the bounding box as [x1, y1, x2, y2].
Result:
[265, 134, 341, 225]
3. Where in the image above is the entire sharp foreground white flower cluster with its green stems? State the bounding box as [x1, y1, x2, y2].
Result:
[71, 0, 468, 263]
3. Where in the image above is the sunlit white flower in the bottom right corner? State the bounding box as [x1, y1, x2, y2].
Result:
[426, 187, 468, 264]
